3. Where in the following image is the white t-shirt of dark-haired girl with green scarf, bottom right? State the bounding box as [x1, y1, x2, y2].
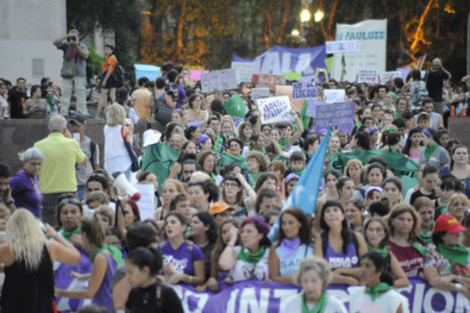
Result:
[348, 286, 410, 313]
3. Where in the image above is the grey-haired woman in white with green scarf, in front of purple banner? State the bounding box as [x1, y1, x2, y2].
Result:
[279, 256, 347, 313]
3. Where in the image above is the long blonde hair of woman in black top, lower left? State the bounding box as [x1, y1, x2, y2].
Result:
[6, 209, 46, 270]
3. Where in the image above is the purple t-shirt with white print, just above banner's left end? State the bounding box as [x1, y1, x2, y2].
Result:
[160, 241, 204, 276]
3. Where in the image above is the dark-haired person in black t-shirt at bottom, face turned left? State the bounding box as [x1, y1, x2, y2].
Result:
[125, 247, 183, 313]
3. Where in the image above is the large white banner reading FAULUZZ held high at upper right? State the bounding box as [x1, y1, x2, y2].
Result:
[331, 20, 387, 81]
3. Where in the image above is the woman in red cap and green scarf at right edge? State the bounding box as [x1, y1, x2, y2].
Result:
[424, 214, 470, 298]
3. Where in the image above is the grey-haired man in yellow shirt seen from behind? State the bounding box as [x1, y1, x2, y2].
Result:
[34, 115, 88, 226]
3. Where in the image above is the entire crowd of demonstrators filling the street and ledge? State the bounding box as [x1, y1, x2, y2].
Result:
[0, 30, 470, 312]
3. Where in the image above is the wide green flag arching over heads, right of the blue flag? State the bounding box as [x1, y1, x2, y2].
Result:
[327, 150, 419, 195]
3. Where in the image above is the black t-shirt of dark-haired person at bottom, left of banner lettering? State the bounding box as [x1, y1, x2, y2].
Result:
[126, 285, 183, 313]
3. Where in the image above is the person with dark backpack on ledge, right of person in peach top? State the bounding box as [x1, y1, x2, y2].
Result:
[147, 77, 178, 129]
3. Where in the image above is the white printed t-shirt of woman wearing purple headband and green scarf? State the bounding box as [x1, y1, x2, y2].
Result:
[230, 246, 269, 281]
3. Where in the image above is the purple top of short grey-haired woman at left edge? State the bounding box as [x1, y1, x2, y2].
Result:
[10, 169, 43, 218]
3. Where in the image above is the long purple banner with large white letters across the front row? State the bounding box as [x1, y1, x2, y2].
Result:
[173, 278, 470, 313]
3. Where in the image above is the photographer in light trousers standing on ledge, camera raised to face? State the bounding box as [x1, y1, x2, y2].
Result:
[53, 29, 88, 116]
